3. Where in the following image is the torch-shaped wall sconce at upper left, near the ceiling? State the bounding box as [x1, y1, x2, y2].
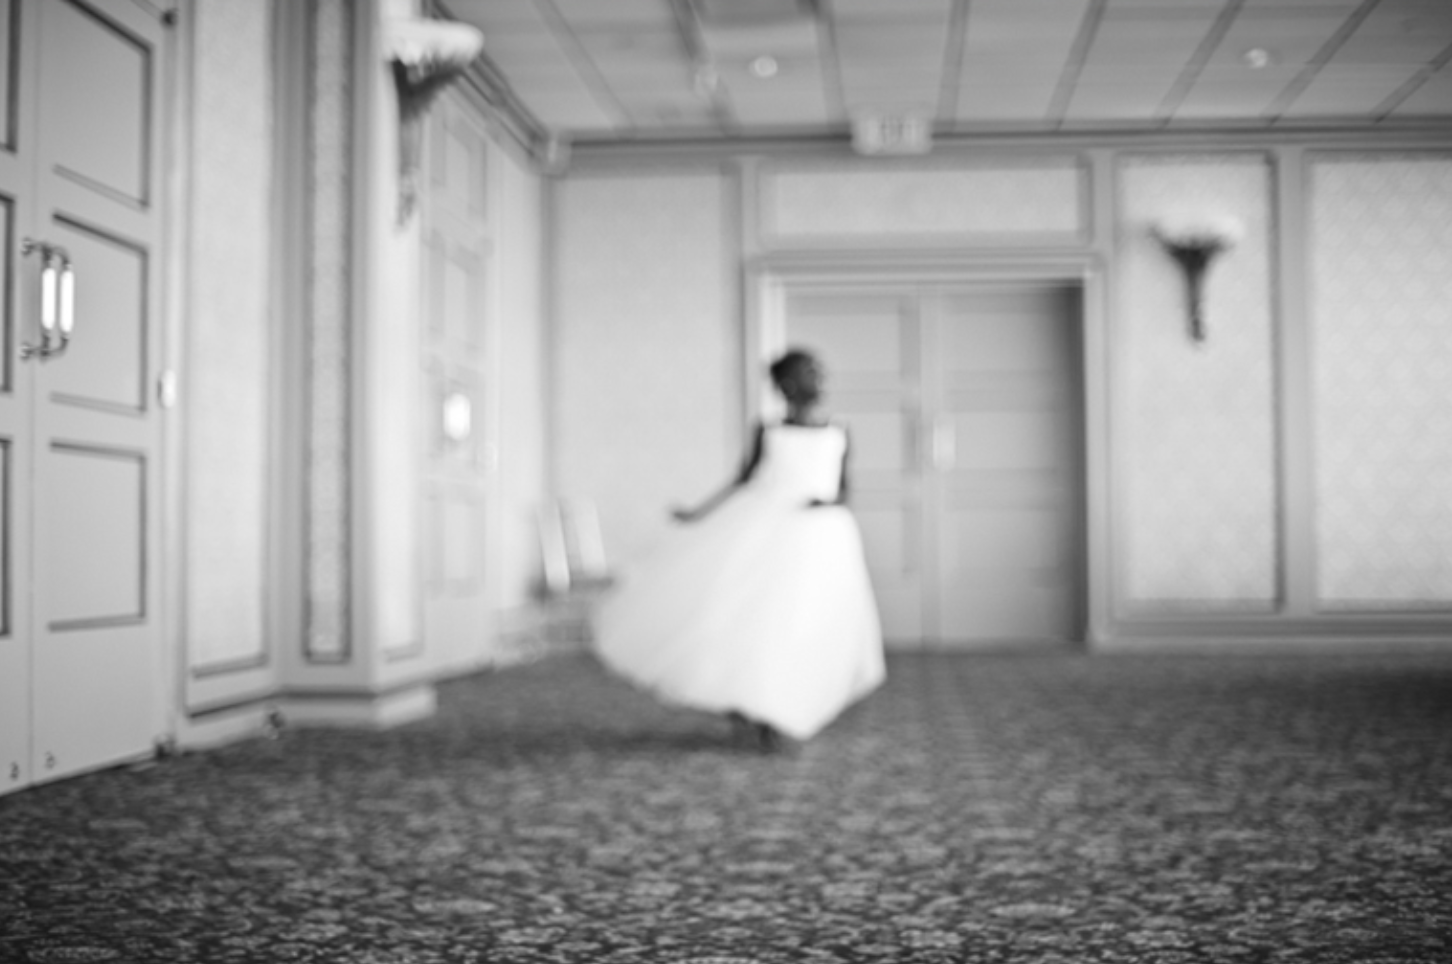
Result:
[383, 19, 484, 225]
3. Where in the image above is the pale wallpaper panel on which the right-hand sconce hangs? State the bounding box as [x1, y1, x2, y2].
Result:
[1112, 154, 1278, 611]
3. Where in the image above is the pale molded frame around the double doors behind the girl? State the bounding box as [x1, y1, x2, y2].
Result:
[741, 250, 1114, 649]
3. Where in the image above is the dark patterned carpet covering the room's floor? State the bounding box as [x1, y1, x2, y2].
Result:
[0, 653, 1452, 964]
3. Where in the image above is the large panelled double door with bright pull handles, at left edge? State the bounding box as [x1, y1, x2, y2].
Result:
[0, 0, 166, 793]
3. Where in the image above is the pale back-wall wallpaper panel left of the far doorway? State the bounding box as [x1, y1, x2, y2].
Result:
[553, 171, 741, 560]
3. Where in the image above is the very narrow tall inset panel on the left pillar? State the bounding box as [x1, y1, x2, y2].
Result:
[306, 0, 353, 662]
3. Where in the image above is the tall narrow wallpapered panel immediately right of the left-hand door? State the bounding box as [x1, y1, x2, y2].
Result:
[184, 0, 274, 672]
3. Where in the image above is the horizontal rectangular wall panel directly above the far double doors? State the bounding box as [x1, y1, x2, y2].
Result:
[761, 157, 1085, 244]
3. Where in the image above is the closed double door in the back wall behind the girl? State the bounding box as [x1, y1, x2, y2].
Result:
[784, 283, 1086, 648]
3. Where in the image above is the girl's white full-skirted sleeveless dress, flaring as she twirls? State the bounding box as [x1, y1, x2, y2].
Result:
[594, 425, 886, 739]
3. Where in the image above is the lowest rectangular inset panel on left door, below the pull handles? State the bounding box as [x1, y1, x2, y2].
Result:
[36, 443, 147, 632]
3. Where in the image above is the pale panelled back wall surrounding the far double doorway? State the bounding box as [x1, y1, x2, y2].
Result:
[553, 135, 1452, 643]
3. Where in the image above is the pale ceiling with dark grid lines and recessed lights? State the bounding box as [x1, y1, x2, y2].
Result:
[436, 0, 1452, 147]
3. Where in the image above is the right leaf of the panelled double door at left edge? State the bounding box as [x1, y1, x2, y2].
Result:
[25, 0, 166, 780]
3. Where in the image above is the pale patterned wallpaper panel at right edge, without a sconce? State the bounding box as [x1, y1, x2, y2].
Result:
[1310, 155, 1452, 610]
